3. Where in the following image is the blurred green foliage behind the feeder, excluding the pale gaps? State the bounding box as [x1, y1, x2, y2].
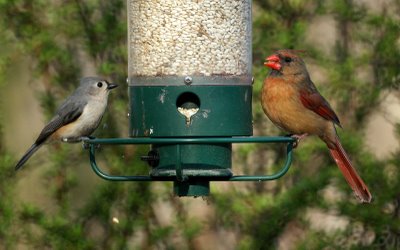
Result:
[0, 0, 400, 249]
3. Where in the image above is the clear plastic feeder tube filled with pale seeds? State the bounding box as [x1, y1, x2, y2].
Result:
[128, 0, 251, 85]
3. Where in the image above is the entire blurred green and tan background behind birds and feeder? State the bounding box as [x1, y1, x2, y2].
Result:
[0, 0, 400, 249]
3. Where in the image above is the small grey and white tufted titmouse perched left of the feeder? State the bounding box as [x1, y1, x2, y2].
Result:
[15, 77, 118, 170]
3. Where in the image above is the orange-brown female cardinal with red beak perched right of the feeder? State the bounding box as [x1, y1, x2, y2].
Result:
[261, 50, 372, 203]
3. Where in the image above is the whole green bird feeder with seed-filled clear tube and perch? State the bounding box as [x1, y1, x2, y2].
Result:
[85, 0, 293, 196]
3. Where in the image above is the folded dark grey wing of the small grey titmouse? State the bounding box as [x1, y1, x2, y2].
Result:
[35, 99, 87, 144]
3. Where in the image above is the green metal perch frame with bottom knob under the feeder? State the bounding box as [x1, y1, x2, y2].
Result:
[84, 137, 295, 196]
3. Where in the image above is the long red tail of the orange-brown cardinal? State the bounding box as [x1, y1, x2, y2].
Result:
[329, 137, 372, 203]
